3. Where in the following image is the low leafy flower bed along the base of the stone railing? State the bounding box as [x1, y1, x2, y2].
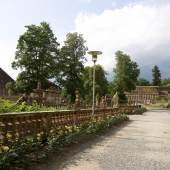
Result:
[0, 114, 128, 170]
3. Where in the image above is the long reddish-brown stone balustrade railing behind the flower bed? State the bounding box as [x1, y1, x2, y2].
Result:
[0, 106, 139, 145]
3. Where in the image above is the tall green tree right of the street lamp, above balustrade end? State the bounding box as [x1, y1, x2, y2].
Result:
[114, 51, 140, 103]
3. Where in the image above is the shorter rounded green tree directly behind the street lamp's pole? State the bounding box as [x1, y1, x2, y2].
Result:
[82, 65, 108, 102]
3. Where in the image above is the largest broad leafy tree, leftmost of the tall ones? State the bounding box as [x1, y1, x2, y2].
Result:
[12, 22, 59, 92]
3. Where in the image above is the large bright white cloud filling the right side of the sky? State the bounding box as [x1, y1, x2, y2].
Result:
[75, 0, 170, 79]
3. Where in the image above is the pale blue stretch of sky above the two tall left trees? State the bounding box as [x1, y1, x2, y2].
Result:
[0, 0, 120, 41]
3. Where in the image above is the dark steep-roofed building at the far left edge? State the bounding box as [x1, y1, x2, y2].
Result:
[0, 68, 14, 96]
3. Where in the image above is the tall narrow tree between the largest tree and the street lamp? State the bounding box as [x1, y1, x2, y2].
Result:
[57, 32, 87, 102]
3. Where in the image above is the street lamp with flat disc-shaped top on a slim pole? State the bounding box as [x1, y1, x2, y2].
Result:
[88, 51, 102, 116]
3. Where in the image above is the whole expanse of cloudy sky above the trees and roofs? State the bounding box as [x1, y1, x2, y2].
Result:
[0, 0, 170, 80]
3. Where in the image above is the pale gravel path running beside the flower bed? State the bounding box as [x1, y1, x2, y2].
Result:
[33, 110, 170, 170]
